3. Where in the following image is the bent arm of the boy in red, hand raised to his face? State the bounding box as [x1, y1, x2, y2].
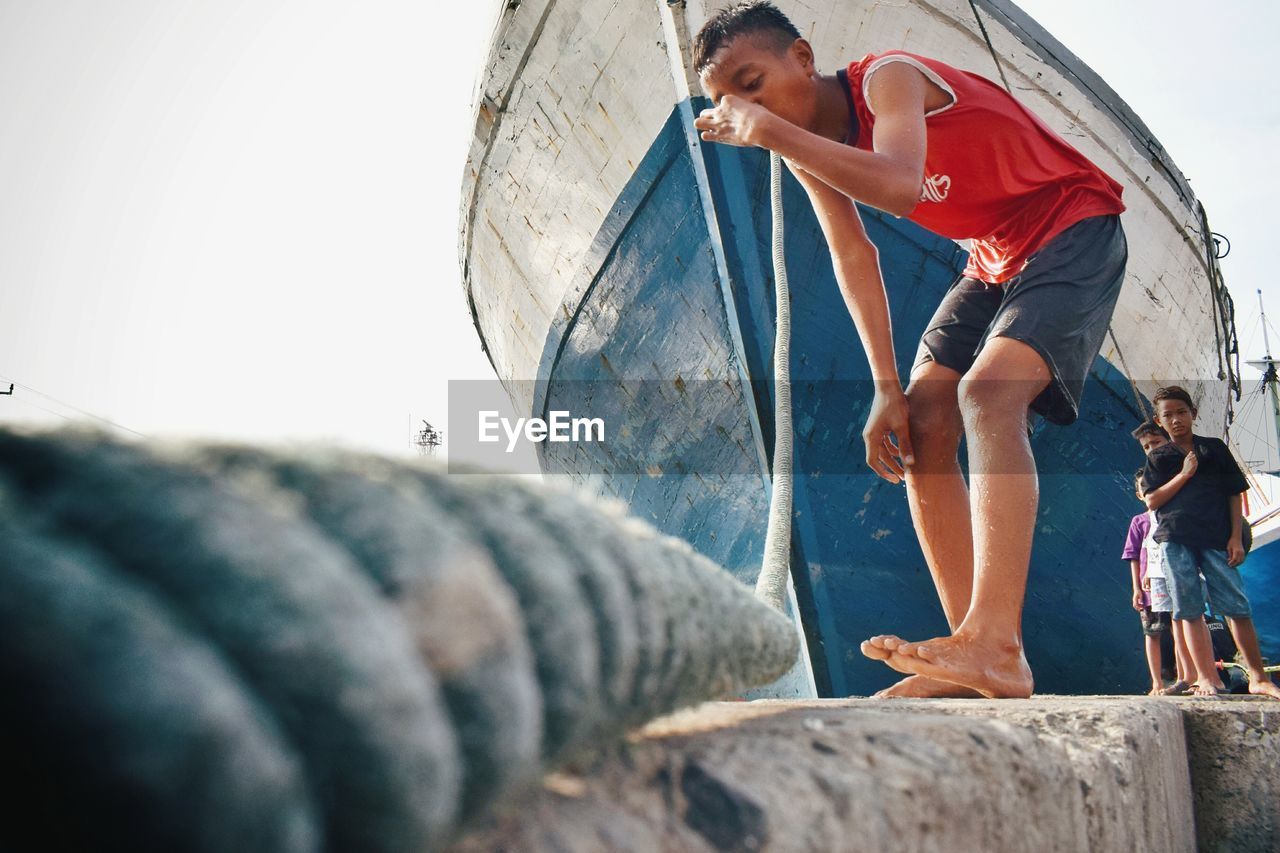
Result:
[694, 63, 929, 216]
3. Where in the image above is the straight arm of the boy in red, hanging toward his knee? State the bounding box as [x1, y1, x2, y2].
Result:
[787, 163, 915, 483]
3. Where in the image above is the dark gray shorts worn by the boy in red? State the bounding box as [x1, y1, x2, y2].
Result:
[911, 215, 1129, 424]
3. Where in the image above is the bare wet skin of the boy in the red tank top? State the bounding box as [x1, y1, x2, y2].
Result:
[695, 35, 1050, 697]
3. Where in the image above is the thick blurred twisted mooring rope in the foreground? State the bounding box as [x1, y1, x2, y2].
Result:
[0, 432, 799, 850]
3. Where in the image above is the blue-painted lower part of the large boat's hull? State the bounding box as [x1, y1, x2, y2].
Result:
[534, 110, 1146, 695]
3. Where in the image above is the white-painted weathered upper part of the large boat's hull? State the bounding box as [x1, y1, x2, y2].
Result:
[460, 0, 1228, 425]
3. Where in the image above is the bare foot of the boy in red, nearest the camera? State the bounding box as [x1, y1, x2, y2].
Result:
[863, 633, 1034, 699]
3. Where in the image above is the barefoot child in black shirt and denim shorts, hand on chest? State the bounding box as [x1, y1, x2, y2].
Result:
[1143, 386, 1280, 699]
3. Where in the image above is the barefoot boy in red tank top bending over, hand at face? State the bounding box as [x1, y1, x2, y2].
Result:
[694, 0, 1128, 697]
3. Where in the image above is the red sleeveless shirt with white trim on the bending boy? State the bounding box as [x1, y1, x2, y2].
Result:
[847, 50, 1124, 284]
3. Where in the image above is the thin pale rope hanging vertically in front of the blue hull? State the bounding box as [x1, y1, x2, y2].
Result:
[755, 152, 792, 611]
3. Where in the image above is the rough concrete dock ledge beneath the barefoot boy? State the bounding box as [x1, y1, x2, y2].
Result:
[453, 695, 1280, 853]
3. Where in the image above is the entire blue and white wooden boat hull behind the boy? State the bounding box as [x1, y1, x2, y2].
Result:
[453, 0, 1229, 695]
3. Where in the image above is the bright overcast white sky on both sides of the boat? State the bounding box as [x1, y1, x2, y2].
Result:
[0, 0, 1280, 453]
